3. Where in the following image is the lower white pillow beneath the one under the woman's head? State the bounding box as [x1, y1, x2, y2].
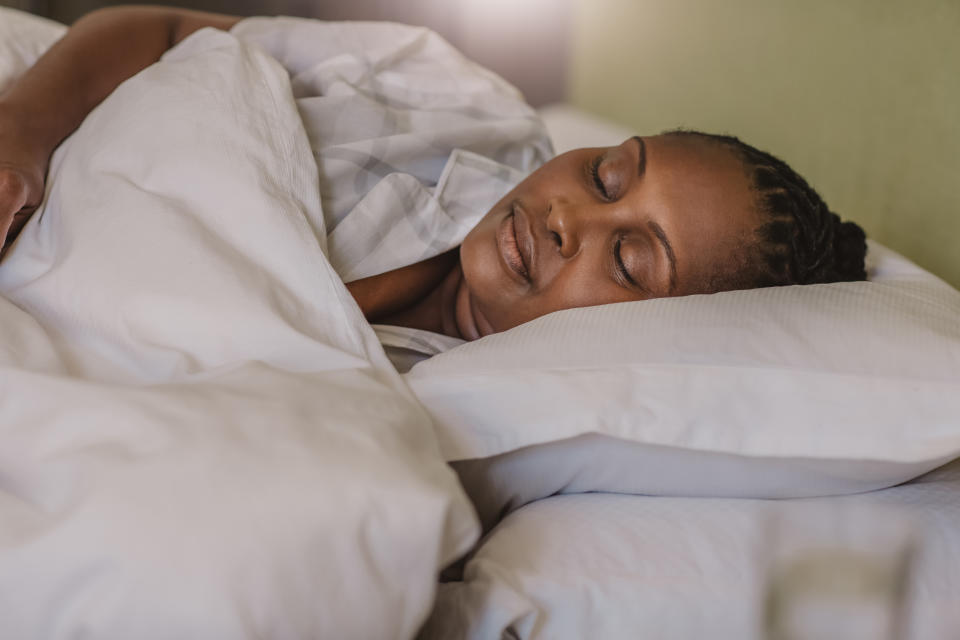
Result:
[420, 462, 960, 640]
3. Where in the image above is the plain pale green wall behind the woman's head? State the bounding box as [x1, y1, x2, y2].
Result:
[569, 0, 960, 286]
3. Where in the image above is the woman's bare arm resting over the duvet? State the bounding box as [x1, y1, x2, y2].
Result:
[0, 6, 240, 255]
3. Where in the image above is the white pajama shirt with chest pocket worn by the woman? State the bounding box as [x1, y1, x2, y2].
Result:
[232, 17, 553, 371]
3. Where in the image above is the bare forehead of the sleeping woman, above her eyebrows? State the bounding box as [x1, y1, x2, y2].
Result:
[643, 135, 761, 289]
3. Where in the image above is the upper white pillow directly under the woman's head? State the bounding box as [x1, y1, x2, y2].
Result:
[406, 243, 960, 526]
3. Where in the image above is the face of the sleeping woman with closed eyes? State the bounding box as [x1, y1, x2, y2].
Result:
[455, 135, 761, 339]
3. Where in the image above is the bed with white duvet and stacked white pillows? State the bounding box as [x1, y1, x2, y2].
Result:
[0, 6, 960, 640]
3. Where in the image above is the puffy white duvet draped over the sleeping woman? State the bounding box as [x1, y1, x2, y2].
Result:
[0, 30, 477, 640]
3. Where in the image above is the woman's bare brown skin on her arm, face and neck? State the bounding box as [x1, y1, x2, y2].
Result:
[0, 7, 761, 340]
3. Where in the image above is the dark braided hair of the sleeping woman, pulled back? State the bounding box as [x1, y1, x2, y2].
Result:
[665, 129, 867, 291]
